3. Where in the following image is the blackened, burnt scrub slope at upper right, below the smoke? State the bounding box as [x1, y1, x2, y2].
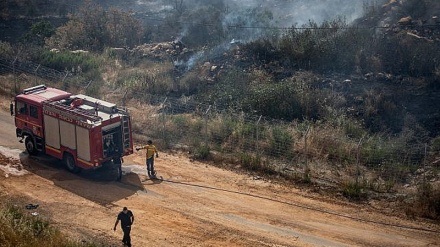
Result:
[200, 1, 440, 139]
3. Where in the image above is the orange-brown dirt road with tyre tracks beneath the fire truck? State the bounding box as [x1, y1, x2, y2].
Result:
[0, 112, 440, 247]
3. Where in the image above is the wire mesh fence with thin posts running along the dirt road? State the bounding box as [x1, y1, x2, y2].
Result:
[0, 59, 440, 192]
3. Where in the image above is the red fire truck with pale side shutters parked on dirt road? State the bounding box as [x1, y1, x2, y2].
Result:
[11, 85, 133, 172]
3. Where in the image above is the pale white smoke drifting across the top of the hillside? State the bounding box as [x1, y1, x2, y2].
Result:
[137, 0, 387, 70]
